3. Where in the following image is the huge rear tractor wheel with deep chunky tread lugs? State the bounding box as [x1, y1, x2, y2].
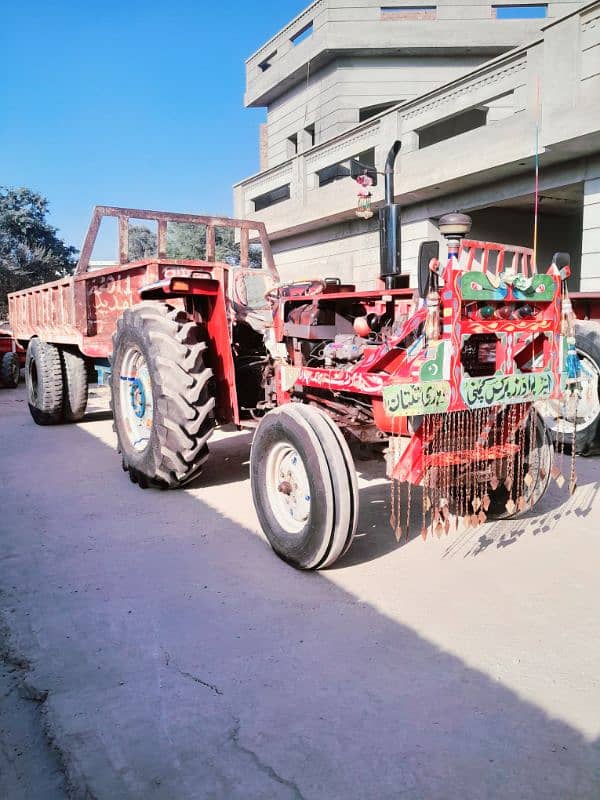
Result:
[111, 303, 215, 488]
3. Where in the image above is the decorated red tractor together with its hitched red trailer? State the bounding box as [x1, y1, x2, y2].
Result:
[9, 144, 579, 569]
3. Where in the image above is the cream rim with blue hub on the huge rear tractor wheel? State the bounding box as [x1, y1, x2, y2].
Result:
[119, 345, 154, 453]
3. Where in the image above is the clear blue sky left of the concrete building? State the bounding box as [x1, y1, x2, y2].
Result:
[0, 0, 308, 252]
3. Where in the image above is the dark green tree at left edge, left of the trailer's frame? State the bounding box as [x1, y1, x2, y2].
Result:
[0, 186, 77, 318]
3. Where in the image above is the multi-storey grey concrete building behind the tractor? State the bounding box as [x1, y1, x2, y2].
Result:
[234, 0, 600, 290]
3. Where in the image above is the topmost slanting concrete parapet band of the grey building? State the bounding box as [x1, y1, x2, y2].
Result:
[244, 0, 581, 106]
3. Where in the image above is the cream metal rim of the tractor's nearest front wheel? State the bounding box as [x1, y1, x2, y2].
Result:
[266, 442, 311, 533]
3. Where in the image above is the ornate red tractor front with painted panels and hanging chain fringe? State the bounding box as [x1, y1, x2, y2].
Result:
[382, 222, 579, 538]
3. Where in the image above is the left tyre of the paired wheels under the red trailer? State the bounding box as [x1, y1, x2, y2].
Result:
[25, 338, 64, 425]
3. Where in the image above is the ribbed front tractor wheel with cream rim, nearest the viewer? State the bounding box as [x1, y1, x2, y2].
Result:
[250, 403, 358, 569]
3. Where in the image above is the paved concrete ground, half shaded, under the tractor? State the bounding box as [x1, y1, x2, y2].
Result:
[0, 389, 600, 800]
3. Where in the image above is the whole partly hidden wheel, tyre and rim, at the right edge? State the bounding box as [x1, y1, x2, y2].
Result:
[539, 322, 600, 455]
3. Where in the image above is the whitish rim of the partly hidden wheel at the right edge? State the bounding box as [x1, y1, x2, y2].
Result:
[538, 350, 600, 435]
